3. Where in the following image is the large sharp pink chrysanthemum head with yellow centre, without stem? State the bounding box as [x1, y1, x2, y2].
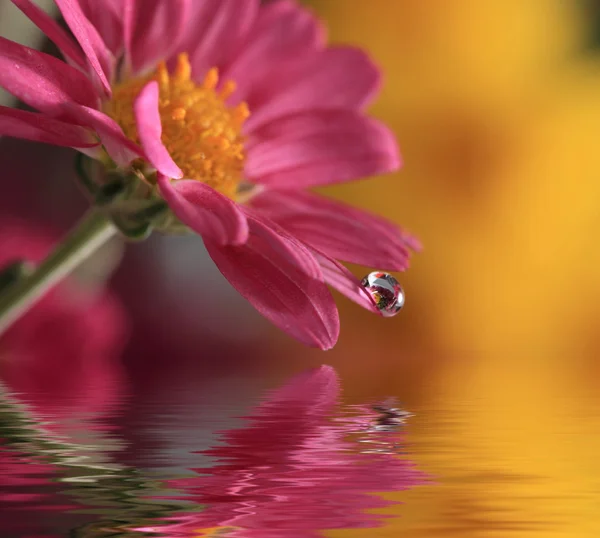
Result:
[0, 0, 417, 349]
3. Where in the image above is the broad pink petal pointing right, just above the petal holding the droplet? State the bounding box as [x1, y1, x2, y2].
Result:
[252, 190, 415, 271]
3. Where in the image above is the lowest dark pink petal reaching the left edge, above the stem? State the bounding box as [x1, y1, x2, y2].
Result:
[0, 106, 99, 148]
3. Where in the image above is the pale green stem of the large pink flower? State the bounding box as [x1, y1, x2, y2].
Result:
[0, 210, 117, 335]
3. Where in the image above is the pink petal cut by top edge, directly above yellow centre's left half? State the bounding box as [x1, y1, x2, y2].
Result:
[126, 0, 194, 73]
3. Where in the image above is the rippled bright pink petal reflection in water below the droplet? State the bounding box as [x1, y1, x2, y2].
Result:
[140, 366, 423, 538]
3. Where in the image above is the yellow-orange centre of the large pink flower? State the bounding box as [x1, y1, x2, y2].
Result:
[104, 53, 250, 198]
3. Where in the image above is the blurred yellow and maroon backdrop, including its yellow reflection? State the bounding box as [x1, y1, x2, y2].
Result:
[0, 0, 600, 538]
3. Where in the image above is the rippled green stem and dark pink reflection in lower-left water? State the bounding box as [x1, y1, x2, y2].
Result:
[0, 384, 188, 538]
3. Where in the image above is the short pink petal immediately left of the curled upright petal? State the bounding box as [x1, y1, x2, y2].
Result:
[64, 103, 146, 166]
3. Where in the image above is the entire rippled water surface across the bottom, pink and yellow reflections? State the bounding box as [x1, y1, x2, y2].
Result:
[0, 358, 600, 538]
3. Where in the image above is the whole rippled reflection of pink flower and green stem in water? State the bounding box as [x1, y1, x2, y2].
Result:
[0, 366, 424, 538]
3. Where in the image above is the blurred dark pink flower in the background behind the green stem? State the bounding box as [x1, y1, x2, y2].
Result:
[0, 221, 127, 419]
